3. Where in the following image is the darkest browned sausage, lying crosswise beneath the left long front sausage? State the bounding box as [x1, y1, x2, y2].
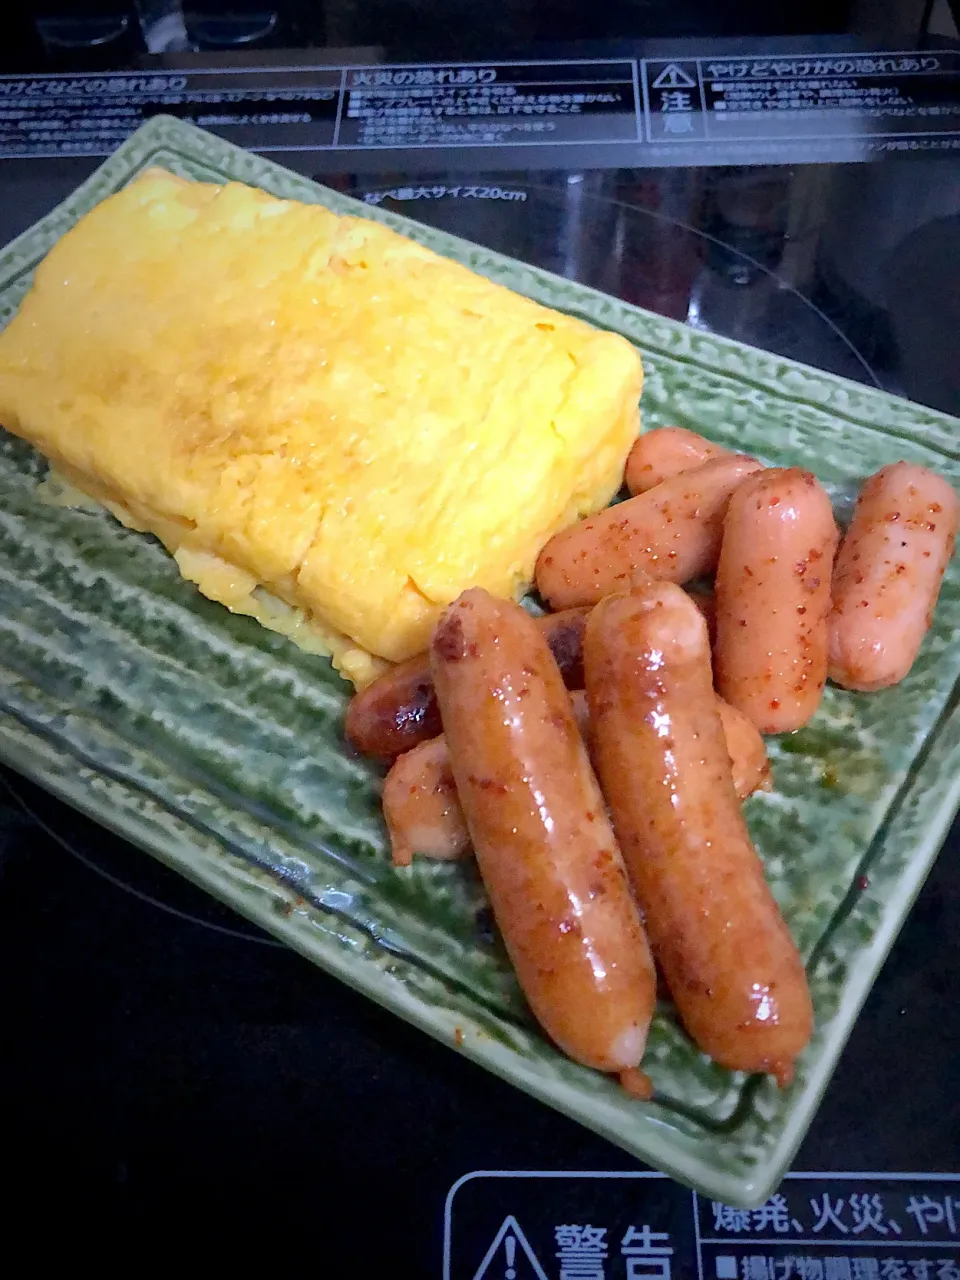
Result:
[344, 609, 588, 760]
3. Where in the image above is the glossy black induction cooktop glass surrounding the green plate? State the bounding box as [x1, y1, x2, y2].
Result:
[0, 32, 960, 1280]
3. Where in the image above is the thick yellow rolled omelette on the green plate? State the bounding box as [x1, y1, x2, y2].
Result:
[0, 169, 643, 686]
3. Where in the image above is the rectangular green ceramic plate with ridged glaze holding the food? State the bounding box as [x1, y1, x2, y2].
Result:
[0, 118, 960, 1203]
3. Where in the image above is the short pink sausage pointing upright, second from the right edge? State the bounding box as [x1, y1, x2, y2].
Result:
[714, 467, 837, 733]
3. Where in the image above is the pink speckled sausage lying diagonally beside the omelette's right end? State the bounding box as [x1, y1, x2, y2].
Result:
[536, 453, 760, 609]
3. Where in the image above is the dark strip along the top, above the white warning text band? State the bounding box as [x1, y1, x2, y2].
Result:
[0, 0, 957, 72]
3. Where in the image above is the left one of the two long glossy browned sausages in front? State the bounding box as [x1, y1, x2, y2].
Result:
[431, 589, 655, 1071]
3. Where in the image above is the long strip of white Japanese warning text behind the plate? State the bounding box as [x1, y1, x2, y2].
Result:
[0, 50, 960, 172]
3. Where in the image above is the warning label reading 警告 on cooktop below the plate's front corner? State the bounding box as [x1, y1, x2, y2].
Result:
[443, 1171, 960, 1280]
